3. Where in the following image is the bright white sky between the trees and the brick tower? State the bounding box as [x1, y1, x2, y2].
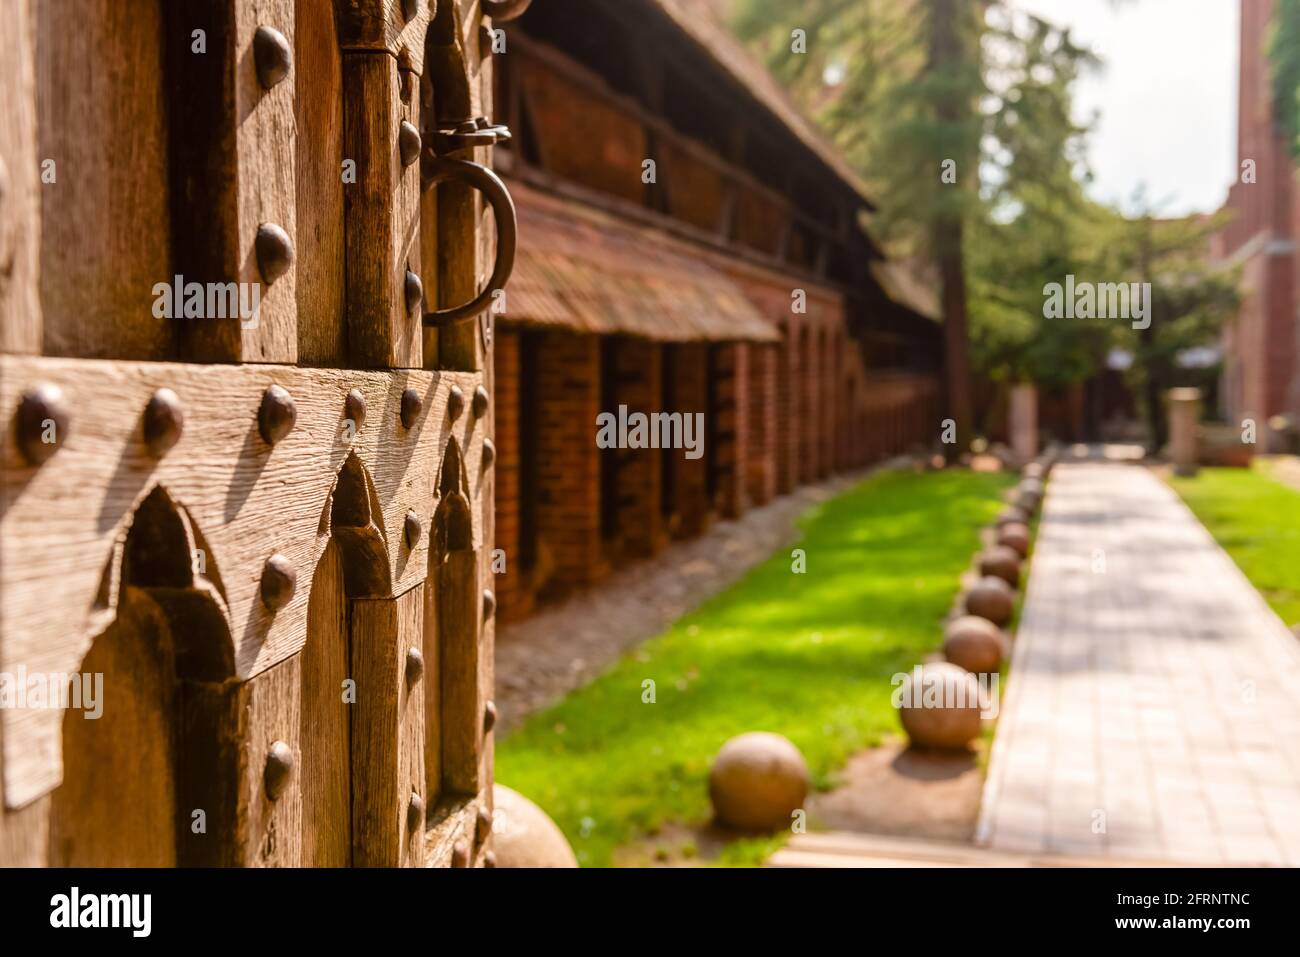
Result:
[1013, 0, 1239, 216]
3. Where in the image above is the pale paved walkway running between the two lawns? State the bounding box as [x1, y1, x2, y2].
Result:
[976, 463, 1300, 866]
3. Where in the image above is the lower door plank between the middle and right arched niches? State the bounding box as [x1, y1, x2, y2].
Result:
[352, 584, 425, 867]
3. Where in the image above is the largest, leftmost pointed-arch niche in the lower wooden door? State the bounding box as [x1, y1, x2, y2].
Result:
[49, 486, 238, 867]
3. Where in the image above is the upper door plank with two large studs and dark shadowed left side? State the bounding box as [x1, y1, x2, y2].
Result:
[166, 0, 297, 363]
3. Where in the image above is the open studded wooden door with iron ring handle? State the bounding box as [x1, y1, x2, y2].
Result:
[0, 0, 527, 866]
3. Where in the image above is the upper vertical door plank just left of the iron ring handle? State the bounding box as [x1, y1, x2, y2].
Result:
[343, 53, 421, 368]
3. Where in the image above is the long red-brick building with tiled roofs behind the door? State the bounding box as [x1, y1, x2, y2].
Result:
[494, 0, 943, 619]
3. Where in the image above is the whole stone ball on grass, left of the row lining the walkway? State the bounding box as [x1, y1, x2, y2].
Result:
[709, 731, 809, 831]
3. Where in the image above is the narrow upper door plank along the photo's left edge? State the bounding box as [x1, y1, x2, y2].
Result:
[0, 0, 42, 352]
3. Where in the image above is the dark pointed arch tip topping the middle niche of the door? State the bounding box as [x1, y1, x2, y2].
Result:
[321, 451, 393, 598]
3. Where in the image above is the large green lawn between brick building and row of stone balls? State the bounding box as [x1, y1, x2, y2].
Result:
[495, 471, 1014, 866]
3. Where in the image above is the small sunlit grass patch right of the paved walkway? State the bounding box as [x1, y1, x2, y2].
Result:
[1170, 463, 1300, 628]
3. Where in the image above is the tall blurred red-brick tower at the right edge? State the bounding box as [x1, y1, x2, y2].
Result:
[1214, 0, 1300, 451]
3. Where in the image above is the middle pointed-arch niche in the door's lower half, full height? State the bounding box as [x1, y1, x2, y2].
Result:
[299, 452, 391, 867]
